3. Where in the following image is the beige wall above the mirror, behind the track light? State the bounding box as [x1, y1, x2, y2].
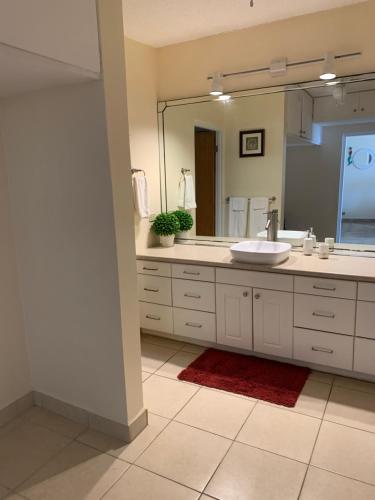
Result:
[157, 0, 375, 100]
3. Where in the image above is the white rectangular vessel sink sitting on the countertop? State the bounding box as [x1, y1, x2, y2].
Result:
[230, 241, 292, 265]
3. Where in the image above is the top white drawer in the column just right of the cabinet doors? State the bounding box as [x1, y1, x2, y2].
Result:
[294, 276, 357, 299]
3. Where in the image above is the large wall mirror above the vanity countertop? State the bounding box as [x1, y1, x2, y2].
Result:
[159, 73, 375, 250]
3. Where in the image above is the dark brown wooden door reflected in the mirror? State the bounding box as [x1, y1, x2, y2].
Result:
[195, 128, 216, 236]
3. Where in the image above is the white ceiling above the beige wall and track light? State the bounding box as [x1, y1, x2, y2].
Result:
[125, 0, 364, 47]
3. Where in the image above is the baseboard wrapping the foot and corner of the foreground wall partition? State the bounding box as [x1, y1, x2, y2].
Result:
[33, 391, 148, 443]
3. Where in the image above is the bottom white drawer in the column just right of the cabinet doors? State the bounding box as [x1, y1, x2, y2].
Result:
[293, 328, 353, 370]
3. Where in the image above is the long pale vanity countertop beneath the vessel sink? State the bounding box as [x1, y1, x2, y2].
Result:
[137, 244, 375, 282]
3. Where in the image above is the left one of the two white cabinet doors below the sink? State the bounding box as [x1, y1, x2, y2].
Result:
[216, 284, 253, 350]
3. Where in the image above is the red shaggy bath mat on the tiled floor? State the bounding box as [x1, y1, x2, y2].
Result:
[178, 349, 310, 408]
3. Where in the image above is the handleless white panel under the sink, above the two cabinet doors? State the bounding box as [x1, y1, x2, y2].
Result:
[216, 267, 293, 292]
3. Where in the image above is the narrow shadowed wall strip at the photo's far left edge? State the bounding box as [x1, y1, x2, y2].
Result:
[0, 137, 31, 410]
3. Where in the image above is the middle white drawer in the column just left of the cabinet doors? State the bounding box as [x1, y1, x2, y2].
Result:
[172, 279, 215, 312]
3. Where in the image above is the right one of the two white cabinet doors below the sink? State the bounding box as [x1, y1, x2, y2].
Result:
[253, 288, 293, 358]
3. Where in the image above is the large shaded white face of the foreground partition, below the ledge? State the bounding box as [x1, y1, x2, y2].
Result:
[1, 82, 140, 423]
